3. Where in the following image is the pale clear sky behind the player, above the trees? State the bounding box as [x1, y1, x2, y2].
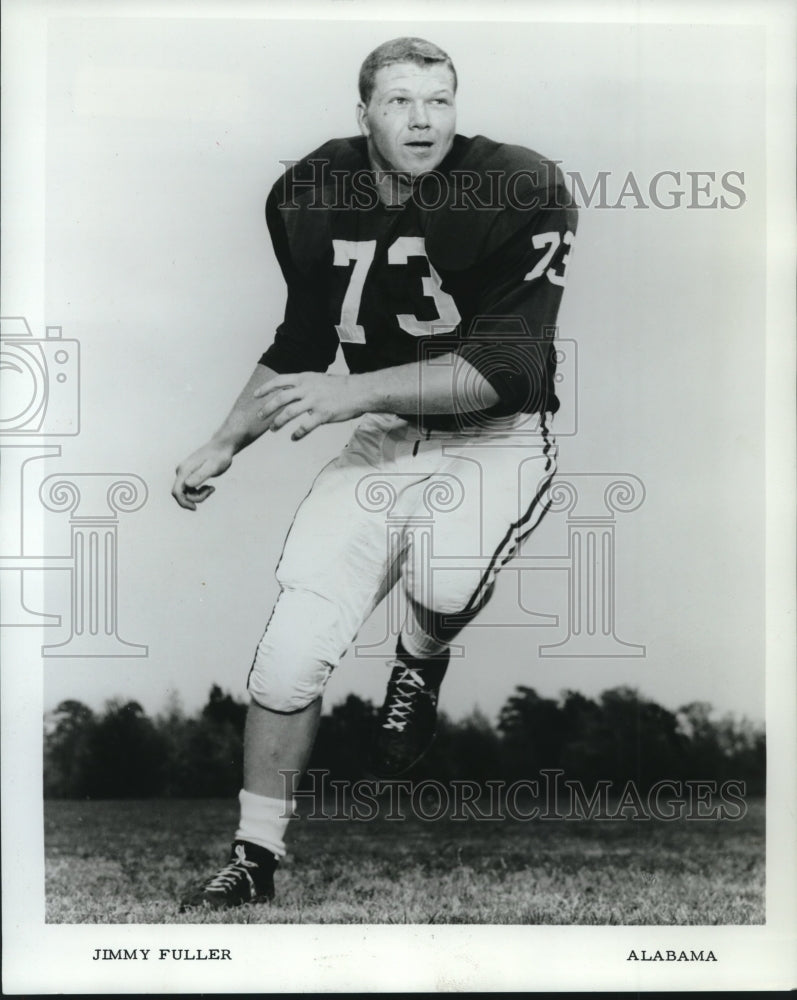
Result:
[4, 11, 766, 721]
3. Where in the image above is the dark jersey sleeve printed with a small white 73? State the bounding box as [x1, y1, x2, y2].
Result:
[457, 205, 577, 415]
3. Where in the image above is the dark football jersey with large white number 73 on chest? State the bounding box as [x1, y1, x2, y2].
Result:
[260, 135, 577, 427]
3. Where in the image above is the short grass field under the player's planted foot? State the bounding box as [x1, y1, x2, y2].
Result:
[45, 800, 764, 925]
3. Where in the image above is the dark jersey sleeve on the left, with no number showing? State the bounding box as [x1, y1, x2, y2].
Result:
[259, 187, 338, 374]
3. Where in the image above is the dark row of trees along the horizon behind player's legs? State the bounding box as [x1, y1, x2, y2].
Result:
[44, 685, 766, 799]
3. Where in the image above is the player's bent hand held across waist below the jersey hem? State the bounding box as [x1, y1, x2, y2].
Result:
[255, 372, 366, 441]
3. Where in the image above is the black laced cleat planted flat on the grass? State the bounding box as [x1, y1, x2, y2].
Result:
[180, 840, 279, 913]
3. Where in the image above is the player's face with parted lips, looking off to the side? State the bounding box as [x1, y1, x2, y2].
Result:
[357, 63, 456, 177]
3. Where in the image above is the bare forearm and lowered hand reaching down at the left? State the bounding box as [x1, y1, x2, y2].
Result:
[172, 364, 276, 510]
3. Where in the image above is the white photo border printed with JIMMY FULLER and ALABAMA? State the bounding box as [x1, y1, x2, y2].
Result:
[2, 0, 797, 993]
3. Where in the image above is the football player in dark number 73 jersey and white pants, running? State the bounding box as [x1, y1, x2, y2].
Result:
[172, 38, 576, 908]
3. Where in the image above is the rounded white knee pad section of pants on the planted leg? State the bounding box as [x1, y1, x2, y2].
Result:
[247, 589, 345, 712]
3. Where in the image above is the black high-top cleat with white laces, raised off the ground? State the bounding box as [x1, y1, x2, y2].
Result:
[371, 644, 448, 778]
